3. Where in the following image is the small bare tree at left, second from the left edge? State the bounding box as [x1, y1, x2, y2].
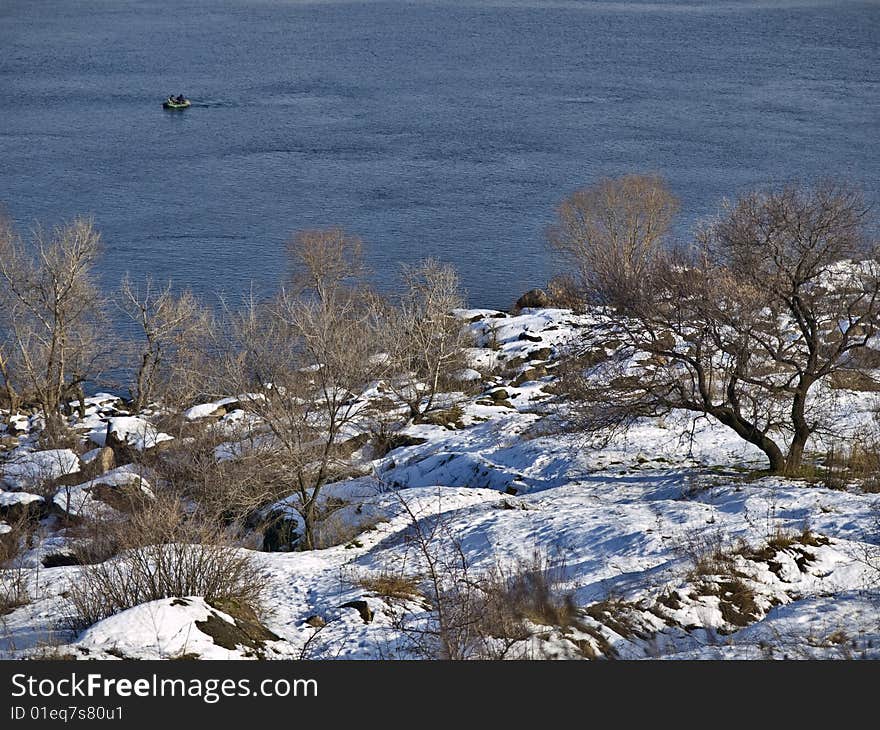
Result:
[118, 276, 210, 412]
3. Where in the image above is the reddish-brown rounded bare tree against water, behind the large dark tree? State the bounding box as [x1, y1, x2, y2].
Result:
[547, 175, 678, 301]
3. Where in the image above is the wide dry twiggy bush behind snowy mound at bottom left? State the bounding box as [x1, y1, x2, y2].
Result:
[69, 497, 265, 629]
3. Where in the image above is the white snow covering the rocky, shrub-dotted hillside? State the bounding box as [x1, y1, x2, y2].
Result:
[0, 310, 880, 659]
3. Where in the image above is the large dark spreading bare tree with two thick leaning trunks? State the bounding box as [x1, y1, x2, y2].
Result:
[569, 184, 880, 473]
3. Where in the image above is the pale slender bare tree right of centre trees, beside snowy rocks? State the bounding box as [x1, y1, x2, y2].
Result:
[382, 259, 467, 420]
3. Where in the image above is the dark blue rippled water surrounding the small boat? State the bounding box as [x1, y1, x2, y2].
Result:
[0, 0, 880, 307]
